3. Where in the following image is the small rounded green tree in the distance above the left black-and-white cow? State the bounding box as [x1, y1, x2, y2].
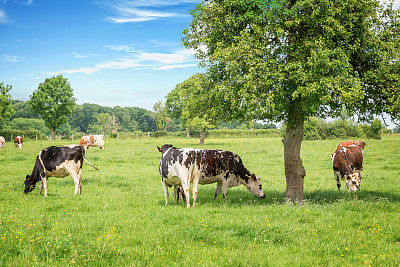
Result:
[29, 75, 76, 138]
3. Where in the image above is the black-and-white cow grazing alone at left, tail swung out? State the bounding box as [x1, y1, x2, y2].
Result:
[24, 145, 98, 197]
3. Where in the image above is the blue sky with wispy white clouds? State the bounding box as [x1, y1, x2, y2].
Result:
[0, 0, 202, 110]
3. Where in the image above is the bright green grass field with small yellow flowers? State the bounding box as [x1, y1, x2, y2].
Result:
[0, 137, 400, 266]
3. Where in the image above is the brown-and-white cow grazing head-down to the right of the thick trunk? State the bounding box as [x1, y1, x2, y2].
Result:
[333, 145, 363, 191]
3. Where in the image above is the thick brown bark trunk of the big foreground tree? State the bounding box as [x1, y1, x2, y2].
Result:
[283, 122, 306, 203]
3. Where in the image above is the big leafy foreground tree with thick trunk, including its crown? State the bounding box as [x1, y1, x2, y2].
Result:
[183, 0, 400, 202]
